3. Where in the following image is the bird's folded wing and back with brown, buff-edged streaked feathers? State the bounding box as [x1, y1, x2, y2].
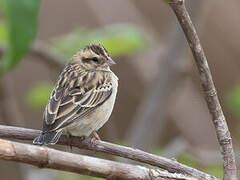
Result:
[43, 67, 113, 132]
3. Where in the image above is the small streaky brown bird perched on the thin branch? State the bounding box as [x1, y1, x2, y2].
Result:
[33, 44, 118, 145]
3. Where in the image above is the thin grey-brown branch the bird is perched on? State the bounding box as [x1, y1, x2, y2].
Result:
[0, 125, 217, 180]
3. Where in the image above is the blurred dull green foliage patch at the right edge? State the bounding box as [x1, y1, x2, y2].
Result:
[226, 85, 240, 118]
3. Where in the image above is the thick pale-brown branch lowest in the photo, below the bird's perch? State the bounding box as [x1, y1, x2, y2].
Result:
[0, 139, 196, 180]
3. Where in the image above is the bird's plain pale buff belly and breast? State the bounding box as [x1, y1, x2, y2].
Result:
[66, 73, 118, 136]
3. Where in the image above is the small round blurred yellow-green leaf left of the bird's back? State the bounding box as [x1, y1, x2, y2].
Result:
[27, 82, 53, 109]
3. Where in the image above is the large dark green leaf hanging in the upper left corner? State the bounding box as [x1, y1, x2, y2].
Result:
[2, 0, 40, 71]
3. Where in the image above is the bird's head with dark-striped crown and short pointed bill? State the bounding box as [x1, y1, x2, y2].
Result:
[73, 44, 116, 70]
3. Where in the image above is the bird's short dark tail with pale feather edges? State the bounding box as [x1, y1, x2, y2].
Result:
[33, 131, 62, 145]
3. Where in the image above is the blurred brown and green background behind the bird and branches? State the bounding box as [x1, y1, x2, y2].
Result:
[0, 0, 240, 180]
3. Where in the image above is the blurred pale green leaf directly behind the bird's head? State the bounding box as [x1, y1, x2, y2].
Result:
[51, 24, 149, 57]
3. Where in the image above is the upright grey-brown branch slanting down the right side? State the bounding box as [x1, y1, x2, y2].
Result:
[169, 0, 237, 180]
